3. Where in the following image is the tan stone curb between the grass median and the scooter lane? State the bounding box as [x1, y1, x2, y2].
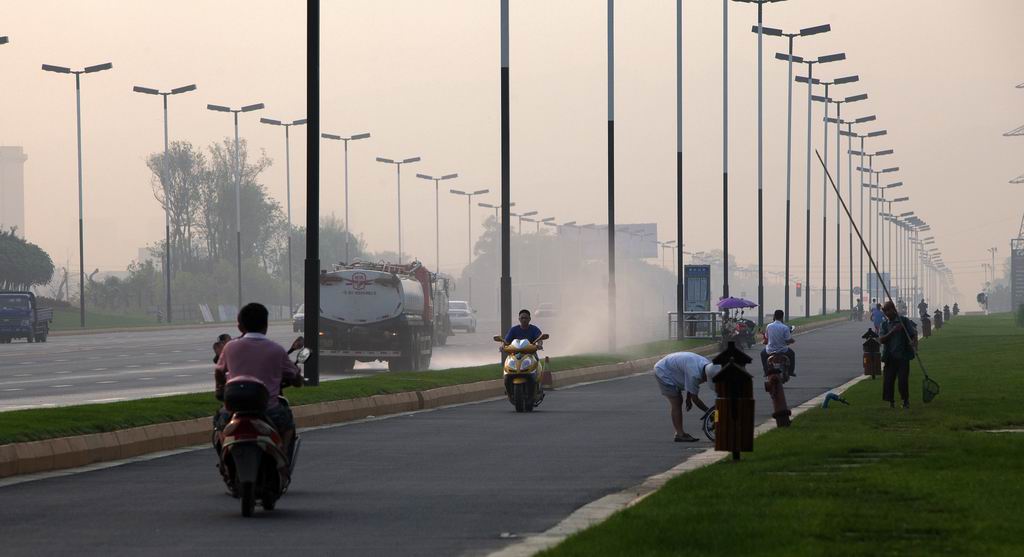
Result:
[0, 319, 847, 478]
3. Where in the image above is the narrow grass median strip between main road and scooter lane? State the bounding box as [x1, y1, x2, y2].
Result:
[0, 340, 708, 444]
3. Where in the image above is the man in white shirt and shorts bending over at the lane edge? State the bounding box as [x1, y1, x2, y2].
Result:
[654, 352, 722, 442]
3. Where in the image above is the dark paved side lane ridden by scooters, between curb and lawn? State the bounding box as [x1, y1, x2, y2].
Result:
[0, 324, 863, 556]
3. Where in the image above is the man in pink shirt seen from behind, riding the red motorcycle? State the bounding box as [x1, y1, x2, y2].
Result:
[213, 303, 302, 455]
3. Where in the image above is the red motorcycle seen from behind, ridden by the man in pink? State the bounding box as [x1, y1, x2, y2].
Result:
[207, 348, 310, 517]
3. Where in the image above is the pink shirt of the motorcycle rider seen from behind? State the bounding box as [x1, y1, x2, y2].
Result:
[215, 333, 299, 409]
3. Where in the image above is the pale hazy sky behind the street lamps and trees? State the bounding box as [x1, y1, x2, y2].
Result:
[0, 0, 1024, 301]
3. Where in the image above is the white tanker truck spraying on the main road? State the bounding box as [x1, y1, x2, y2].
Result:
[319, 261, 444, 372]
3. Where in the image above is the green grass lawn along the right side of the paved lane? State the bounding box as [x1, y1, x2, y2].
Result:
[543, 314, 1024, 557]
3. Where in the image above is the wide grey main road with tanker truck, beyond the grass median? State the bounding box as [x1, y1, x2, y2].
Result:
[0, 325, 495, 412]
